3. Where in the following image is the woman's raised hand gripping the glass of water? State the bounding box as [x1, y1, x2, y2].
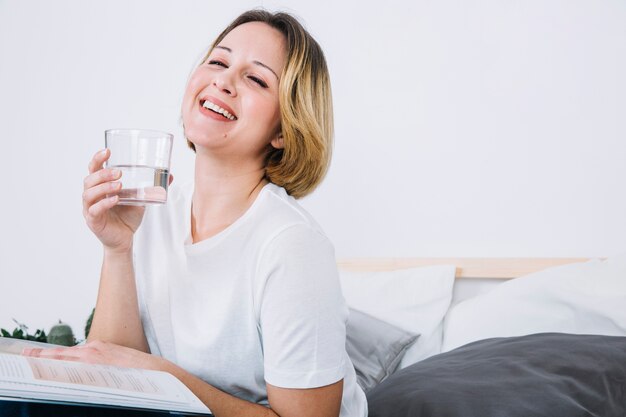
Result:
[83, 149, 172, 252]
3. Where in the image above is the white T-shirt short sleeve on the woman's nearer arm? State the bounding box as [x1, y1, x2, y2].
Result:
[259, 224, 348, 388]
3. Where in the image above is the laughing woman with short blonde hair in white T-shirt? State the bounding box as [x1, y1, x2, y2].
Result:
[26, 10, 367, 417]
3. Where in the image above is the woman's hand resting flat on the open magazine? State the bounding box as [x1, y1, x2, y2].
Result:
[22, 340, 164, 370]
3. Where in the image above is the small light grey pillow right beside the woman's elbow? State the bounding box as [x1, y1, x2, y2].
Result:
[346, 309, 419, 392]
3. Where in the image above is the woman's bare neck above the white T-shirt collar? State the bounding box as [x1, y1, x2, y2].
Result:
[191, 150, 268, 243]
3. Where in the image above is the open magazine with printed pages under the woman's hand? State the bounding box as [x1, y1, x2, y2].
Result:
[0, 337, 211, 416]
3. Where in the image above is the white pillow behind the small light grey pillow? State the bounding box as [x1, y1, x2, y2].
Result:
[340, 265, 456, 368]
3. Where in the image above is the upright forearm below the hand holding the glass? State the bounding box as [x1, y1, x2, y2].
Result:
[89, 248, 149, 352]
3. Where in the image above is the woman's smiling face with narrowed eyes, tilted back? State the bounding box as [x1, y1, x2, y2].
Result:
[182, 22, 286, 160]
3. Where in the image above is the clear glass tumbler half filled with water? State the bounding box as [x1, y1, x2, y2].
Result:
[104, 129, 174, 206]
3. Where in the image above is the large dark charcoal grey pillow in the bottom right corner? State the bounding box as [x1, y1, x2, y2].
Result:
[367, 333, 626, 417]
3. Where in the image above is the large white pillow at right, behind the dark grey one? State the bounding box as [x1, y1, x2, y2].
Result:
[443, 253, 626, 352]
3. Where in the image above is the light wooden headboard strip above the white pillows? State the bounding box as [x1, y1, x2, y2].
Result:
[337, 258, 589, 279]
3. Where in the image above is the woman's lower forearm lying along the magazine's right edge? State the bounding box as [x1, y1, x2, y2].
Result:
[162, 360, 278, 417]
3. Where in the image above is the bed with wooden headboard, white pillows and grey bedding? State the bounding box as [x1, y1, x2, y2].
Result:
[339, 254, 626, 417]
